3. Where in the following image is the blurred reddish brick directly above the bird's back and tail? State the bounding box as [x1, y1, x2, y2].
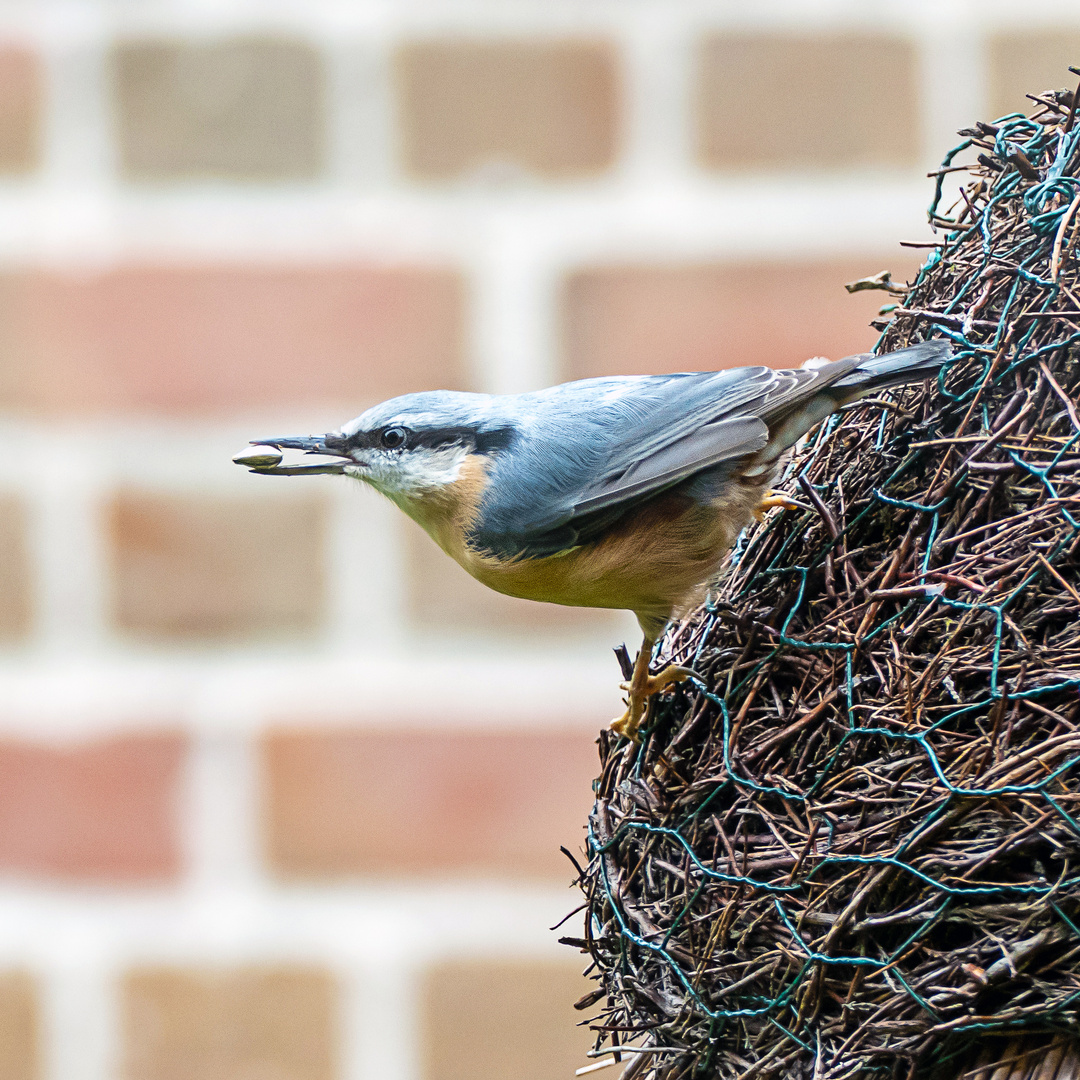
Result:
[562, 256, 916, 379]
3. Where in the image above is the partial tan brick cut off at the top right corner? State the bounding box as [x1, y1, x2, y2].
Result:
[986, 31, 1080, 119]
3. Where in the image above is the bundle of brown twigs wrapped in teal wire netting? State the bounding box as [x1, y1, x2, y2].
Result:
[563, 82, 1080, 1080]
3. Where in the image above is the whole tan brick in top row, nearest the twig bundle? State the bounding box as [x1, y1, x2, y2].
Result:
[697, 33, 919, 171]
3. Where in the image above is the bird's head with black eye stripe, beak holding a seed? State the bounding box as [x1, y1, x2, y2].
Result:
[233, 390, 515, 512]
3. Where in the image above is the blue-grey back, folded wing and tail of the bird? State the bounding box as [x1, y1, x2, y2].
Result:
[474, 340, 950, 555]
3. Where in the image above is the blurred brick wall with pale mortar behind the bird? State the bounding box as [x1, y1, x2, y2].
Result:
[0, 0, 1080, 1080]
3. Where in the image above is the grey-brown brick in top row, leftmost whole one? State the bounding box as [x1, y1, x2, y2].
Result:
[111, 38, 326, 181]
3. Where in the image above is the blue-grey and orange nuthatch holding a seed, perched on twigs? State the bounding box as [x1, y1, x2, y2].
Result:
[233, 338, 951, 741]
